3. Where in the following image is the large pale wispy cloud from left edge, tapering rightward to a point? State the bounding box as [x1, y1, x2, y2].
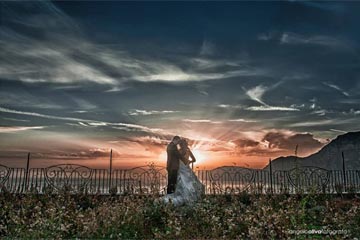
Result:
[0, 30, 265, 86]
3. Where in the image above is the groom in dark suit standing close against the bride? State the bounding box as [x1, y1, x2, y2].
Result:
[166, 136, 181, 194]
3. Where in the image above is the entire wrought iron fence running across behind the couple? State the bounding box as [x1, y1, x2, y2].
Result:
[0, 164, 360, 194]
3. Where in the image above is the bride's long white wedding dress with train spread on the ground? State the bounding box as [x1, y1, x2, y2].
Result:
[162, 161, 205, 206]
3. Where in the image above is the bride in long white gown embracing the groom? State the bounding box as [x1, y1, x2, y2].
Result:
[163, 138, 205, 206]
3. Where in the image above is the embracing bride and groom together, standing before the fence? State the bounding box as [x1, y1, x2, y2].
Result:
[163, 136, 205, 205]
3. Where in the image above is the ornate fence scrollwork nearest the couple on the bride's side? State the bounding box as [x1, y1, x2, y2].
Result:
[208, 167, 255, 194]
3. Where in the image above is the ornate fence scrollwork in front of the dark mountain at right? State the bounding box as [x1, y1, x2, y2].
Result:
[287, 166, 330, 192]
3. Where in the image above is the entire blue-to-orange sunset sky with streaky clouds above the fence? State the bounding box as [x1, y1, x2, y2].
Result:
[0, 1, 360, 169]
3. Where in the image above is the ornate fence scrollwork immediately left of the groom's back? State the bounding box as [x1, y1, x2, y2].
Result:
[125, 164, 167, 194]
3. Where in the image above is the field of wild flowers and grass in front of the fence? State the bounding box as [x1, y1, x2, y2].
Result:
[0, 192, 360, 239]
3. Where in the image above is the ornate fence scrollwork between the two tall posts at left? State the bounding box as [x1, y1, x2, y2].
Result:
[44, 164, 93, 191]
